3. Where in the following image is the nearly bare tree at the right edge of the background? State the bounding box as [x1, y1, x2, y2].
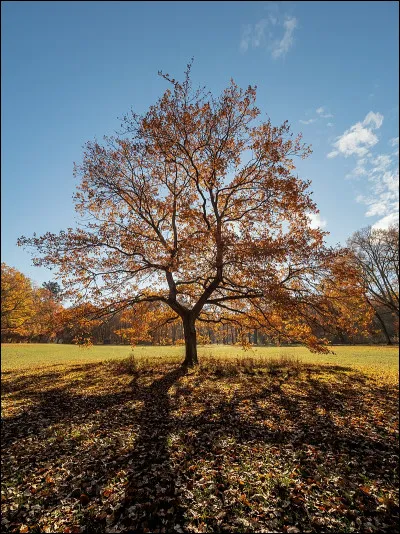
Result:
[348, 225, 399, 344]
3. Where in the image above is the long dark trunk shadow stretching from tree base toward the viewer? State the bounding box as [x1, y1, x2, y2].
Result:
[112, 366, 187, 532]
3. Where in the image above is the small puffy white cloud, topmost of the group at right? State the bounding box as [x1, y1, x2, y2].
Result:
[327, 111, 383, 158]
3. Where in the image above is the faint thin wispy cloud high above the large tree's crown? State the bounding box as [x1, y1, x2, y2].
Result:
[240, 14, 297, 59]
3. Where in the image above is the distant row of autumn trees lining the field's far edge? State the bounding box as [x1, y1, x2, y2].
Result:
[1, 226, 399, 345]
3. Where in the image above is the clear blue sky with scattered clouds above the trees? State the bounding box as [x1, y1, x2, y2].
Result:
[1, 1, 399, 285]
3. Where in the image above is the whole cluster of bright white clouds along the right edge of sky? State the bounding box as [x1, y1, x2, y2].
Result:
[327, 111, 399, 228]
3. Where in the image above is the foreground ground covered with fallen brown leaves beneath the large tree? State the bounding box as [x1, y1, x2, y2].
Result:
[1, 357, 399, 533]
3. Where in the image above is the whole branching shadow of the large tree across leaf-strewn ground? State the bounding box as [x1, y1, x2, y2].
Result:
[2, 364, 398, 533]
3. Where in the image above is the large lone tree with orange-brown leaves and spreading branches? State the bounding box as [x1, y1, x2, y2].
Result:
[18, 64, 368, 365]
